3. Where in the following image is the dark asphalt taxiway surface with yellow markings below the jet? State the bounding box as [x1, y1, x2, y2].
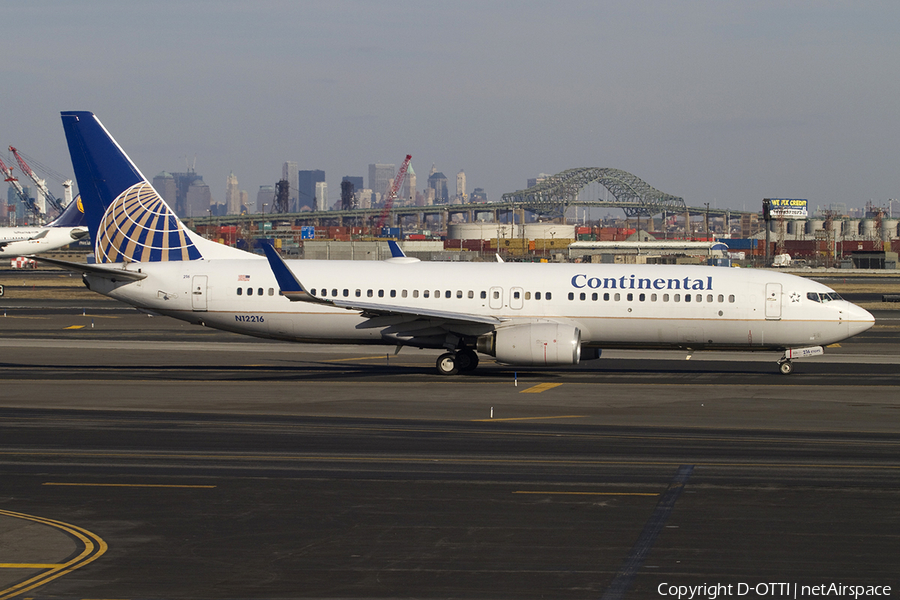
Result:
[0, 301, 900, 600]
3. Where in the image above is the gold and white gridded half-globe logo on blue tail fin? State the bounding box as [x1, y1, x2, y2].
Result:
[94, 181, 201, 263]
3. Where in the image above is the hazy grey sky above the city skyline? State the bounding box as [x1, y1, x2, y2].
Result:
[0, 0, 900, 216]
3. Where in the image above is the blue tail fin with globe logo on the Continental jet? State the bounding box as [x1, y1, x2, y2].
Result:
[62, 111, 202, 263]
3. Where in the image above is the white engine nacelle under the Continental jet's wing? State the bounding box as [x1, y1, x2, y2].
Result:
[476, 323, 581, 365]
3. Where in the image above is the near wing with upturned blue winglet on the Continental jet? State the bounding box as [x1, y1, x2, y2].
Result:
[263, 244, 504, 331]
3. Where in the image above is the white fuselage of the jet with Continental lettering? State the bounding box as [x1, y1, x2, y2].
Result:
[85, 258, 873, 350]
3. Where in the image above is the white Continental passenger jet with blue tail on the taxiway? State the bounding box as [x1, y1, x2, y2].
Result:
[38, 112, 874, 375]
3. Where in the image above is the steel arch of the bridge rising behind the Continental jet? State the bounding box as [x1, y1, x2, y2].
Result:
[503, 167, 686, 217]
